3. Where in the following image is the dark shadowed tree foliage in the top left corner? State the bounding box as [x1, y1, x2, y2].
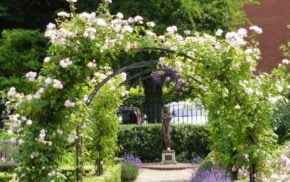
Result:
[0, 0, 102, 31]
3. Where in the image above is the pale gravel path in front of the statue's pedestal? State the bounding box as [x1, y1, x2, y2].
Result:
[135, 169, 194, 182]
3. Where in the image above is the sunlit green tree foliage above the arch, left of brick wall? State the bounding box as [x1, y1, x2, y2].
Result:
[110, 0, 254, 33]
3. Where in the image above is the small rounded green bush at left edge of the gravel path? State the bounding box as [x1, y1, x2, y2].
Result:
[121, 162, 139, 182]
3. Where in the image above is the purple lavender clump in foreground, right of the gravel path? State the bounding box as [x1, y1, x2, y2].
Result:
[190, 167, 231, 182]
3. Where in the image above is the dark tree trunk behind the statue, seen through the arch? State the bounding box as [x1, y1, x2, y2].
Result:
[143, 78, 163, 123]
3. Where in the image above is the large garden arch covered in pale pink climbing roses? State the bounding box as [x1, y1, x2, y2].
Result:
[8, 0, 289, 181]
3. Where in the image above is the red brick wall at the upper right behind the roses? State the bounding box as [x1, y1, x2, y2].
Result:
[244, 0, 290, 72]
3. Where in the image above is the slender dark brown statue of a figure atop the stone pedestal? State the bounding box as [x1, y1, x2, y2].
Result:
[162, 106, 172, 150]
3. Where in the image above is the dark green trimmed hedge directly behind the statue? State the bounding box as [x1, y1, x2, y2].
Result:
[118, 124, 209, 162]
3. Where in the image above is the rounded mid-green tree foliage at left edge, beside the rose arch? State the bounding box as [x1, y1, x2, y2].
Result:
[0, 29, 48, 93]
